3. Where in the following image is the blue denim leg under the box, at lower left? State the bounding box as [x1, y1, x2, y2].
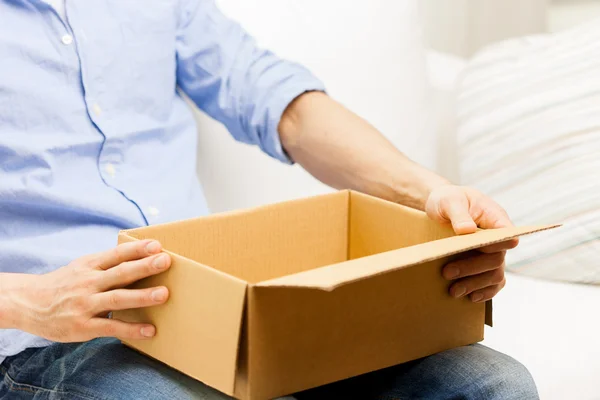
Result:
[0, 339, 229, 400]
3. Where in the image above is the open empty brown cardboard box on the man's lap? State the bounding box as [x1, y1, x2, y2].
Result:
[114, 191, 549, 400]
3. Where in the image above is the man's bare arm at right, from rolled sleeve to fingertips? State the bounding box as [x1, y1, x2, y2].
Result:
[279, 92, 518, 302]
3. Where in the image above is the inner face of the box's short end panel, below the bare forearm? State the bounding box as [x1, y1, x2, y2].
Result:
[348, 192, 454, 259]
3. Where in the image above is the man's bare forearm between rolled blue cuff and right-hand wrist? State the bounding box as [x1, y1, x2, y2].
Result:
[279, 92, 449, 210]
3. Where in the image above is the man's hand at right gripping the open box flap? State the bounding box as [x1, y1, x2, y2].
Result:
[425, 185, 519, 302]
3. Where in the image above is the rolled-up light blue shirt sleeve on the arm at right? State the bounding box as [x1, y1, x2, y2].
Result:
[177, 0, 324, 163]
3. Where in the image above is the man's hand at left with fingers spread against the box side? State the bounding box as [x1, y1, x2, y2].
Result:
[11, 240, 171, 342]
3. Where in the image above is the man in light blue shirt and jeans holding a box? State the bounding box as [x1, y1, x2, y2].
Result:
[0, 0, 537, 399]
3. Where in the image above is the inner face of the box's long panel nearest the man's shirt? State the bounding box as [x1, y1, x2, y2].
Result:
[128, 191, 349, 283]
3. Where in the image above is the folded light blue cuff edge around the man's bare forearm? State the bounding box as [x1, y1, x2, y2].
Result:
[263, 72, 325, 164]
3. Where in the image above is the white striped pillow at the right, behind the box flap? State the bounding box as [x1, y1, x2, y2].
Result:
[457, 21, 600, 284]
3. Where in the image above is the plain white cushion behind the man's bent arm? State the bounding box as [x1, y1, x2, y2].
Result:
[198, 0, 437, 211]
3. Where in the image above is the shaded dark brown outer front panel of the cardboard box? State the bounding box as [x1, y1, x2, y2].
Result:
[248, 258, 485, 399]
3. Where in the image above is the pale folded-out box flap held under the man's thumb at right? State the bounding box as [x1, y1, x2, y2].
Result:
[255, 225, 558, 290]
